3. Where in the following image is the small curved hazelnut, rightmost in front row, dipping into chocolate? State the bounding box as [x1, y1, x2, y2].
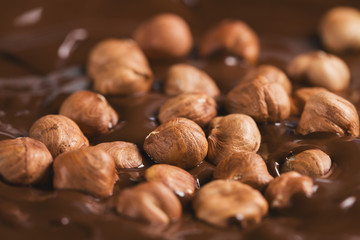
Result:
[264, 171, 314, 208]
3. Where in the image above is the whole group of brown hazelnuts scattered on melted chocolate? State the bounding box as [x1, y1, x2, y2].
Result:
[0, 7, 360, 227]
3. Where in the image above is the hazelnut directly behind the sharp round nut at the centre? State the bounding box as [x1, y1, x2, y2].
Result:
[158, 93, 217, 127]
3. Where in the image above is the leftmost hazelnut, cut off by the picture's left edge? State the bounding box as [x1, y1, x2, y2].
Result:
[0, 137, 53, 185]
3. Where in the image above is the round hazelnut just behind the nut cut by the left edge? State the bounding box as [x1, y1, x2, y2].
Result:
[29, 115, 89, 158]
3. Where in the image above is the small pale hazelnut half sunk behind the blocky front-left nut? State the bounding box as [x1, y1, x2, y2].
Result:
[96, 141, 143, 169]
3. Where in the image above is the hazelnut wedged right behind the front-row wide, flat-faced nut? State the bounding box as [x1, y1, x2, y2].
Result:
[214, 152, 274, 191]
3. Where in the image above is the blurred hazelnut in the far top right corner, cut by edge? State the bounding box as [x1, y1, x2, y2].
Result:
[319, 7, 360, 52]
